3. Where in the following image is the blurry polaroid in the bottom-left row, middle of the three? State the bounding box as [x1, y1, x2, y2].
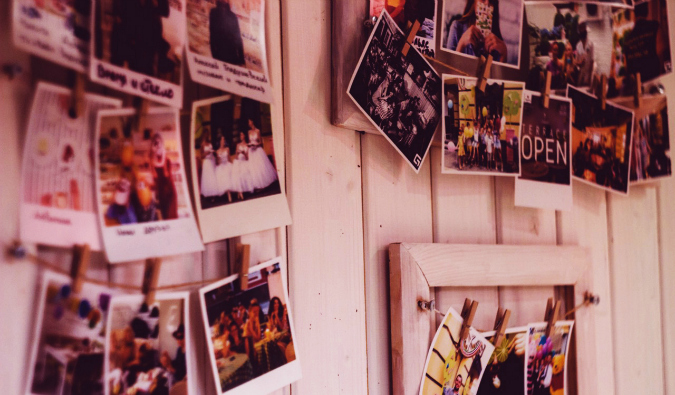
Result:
[105, 292, 190, 395]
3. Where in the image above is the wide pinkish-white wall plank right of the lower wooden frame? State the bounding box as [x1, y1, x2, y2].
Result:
[607, 187, 672, 395]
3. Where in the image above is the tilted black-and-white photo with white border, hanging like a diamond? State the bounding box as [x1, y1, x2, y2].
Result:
[347, 10, 441, 173]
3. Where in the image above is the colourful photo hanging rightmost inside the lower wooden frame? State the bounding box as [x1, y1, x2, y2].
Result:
[521, 321, 574, 395]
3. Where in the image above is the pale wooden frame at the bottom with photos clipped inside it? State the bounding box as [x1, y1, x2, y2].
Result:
[389, 243, 603, 395]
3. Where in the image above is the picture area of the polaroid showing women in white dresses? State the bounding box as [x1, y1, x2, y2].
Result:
[192, 95, 281, 210]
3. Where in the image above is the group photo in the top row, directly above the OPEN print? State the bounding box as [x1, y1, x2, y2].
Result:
[525, 2, 613, 92]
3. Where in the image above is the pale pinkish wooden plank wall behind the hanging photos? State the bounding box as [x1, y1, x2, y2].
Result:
[0, 0, 675, 395]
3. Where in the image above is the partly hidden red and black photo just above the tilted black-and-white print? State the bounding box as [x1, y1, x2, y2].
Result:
[369, 0, 438, 58]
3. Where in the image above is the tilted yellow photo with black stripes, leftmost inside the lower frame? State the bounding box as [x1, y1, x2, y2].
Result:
[419, 308, 494, 395]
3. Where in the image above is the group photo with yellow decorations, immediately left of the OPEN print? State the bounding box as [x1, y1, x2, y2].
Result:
[441, 74, 524, 177]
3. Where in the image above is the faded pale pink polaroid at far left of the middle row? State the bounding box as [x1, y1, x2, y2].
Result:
[20, 82, 122, 251]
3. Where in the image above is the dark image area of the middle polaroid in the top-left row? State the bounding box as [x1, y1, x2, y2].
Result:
[94, 0, 185, 85]
